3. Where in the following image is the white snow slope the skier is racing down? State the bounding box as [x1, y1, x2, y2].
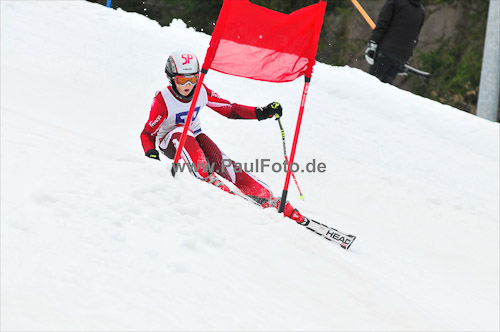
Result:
[1, 1, 500, 331]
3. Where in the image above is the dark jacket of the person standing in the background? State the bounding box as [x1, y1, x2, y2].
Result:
[370, 0, 425, 59]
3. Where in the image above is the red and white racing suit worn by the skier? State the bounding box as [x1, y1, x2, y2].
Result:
[141, 85, 304, 223]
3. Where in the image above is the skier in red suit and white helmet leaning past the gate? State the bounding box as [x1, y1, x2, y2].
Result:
[141, 50, 309, 225]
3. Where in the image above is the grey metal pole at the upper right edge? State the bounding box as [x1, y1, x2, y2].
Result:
[477, 0, 500, 122]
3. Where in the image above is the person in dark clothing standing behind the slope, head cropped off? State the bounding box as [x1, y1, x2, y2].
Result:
[365, 0, 425, 84]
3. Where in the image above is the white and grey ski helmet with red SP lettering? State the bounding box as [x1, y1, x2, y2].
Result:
[165, 50, 200, 101]
